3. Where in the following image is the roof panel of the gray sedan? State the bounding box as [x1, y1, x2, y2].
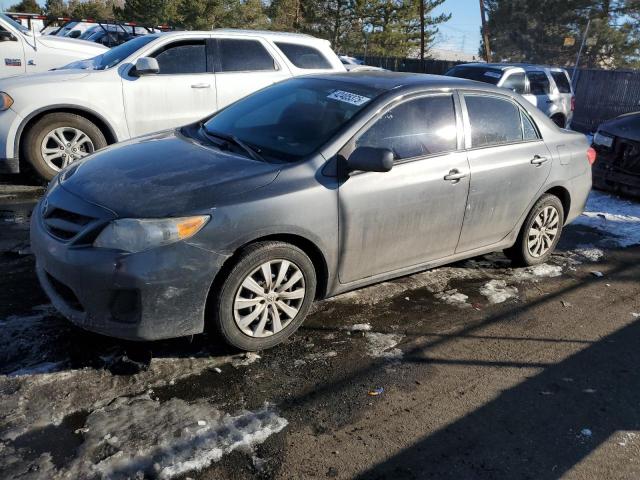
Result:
[307, 70, 502, 91]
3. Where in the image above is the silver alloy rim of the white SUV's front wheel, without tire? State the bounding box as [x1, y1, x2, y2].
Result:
[40, 127, 95, 170]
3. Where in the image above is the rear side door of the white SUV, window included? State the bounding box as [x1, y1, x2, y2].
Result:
[213, 37, 291, 109]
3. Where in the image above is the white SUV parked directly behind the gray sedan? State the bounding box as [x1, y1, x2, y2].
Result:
[0, 30, 345, 179]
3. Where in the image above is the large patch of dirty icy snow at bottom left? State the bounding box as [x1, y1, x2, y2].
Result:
[0, 395, 288, 480]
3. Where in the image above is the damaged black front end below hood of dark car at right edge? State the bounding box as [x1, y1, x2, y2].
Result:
[593, 137, 640, 197]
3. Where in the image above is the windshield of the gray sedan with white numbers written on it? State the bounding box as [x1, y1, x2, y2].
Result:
[203, 78, 382, 161]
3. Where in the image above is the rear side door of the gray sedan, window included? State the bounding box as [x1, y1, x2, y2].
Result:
[456, 92, 552, 253]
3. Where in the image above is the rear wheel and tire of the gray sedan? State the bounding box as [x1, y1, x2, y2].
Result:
[504, 193, 564, 267]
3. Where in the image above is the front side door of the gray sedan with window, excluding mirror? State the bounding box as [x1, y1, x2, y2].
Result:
[338, 94, 469, 283]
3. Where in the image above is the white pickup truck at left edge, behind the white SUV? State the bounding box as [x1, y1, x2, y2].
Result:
[0, 14, 107, 78]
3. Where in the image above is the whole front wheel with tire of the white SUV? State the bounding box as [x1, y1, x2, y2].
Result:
[23, 113, 107, 180]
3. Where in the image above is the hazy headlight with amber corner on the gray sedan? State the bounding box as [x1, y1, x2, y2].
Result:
[93, 215, 211, 253]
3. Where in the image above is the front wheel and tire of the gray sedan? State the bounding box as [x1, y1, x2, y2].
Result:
[210, 242, 316, 351]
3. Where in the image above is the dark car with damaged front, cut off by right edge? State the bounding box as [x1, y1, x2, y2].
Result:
[593, 112, 640, 196]
